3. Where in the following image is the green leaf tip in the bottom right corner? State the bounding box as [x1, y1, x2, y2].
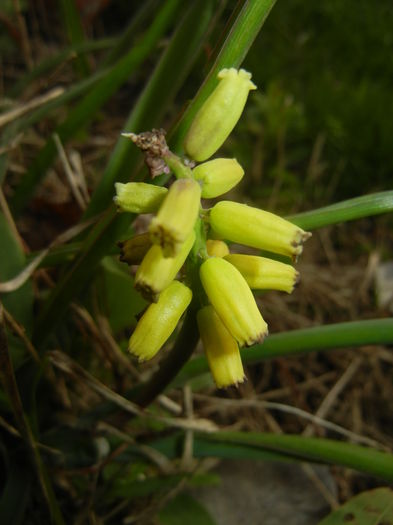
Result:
[319, 487, 393, 525]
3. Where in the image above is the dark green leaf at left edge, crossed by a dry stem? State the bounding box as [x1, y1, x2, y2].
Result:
[0, 213, 33, 333]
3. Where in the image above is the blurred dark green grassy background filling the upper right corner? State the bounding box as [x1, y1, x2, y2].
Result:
[237, 0, 393, 207]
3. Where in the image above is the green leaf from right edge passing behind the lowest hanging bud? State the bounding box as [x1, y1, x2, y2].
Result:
[171, 319, 393, 387]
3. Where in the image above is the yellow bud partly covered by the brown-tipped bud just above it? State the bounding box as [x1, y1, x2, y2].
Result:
[135, 231, 195, 301]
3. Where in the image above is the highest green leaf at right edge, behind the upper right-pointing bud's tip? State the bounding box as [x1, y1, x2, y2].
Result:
[287, 191, 393, 230]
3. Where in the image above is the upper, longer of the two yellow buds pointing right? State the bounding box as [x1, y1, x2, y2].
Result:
[209, 201, 311, 258]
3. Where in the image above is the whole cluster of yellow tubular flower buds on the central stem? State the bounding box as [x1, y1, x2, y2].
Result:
[115, 68, 311, 387]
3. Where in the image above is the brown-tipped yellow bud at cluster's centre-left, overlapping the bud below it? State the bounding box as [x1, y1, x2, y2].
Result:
[150, 179, 201, 257]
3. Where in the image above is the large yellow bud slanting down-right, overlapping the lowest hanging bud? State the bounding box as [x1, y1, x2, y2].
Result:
[200, 257, 267, 346]
